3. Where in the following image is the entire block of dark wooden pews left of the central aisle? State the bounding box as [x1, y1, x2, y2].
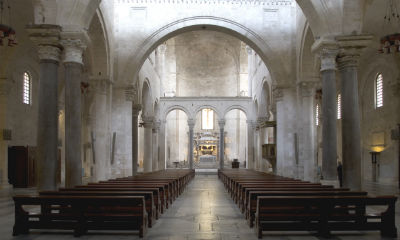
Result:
[13, 169, 194, 237]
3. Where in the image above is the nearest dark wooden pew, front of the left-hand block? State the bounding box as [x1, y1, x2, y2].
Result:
[13, 195, 147, 238]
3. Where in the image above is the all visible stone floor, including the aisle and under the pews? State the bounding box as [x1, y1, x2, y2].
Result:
[0, 175, 400, 240]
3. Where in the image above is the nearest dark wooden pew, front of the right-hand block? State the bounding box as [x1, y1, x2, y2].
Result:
[255, 196, 397, 238]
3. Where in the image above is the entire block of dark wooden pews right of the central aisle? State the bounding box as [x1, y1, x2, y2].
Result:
[218, 169, 397, 238]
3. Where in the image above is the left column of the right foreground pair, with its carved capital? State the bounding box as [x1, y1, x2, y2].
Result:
[313, 41, 338, 185]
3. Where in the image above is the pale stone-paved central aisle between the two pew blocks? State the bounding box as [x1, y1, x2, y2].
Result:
[146, 175, 257, 240]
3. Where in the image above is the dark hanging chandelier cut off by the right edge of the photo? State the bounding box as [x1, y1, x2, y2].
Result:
[379, 0, 400, 53]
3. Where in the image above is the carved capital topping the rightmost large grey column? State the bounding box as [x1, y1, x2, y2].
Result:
[336, 35, 373, 69]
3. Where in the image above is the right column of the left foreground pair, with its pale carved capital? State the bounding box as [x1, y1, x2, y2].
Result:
[61, 39, 86, 188]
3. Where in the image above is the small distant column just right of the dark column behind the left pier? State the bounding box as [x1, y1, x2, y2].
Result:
[142, 117, 153, 172]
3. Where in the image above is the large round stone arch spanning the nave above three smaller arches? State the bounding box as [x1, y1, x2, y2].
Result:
[123, 16, 287, 87]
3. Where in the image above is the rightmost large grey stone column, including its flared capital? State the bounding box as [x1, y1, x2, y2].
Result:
[335, 36, 372, 190]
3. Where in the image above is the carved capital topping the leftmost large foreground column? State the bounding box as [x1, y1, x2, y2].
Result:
[26, 24, 62, 62]
